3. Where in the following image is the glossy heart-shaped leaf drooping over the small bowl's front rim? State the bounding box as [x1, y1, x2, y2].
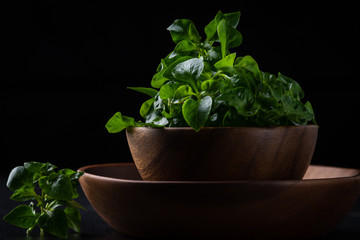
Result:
[182, 96, 212, 132]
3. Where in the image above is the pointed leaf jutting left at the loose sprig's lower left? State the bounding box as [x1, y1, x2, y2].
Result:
[3, 205, 36, 229]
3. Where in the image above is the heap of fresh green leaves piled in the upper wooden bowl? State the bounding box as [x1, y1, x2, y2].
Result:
[106, 11, 316, 133]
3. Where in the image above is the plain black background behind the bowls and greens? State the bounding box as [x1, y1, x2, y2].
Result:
[0, 1, 360, 174]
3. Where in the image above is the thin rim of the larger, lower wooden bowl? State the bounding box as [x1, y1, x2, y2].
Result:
[77, 162, 360, 185]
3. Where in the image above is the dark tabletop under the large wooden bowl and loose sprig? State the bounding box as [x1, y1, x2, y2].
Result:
[0, 176, 360, 240]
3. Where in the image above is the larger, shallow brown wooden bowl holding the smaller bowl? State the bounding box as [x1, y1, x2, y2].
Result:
[79, 164, 360, 240]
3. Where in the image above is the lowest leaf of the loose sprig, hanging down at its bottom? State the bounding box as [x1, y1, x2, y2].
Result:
[38, 208, 68, 238]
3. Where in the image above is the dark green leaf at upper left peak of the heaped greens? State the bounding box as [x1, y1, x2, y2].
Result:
[167, 19, 201, 43]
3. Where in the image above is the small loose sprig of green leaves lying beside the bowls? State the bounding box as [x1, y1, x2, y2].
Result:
[3, 162, 85, 238]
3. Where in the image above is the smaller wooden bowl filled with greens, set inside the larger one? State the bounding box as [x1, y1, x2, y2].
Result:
[126, 125, 318, 181]
